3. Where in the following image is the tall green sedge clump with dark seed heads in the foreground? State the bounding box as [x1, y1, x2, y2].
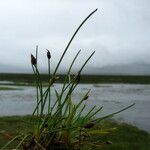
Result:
[1, 9, 134, 150]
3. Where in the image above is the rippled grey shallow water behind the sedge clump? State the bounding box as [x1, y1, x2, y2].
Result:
[0, 84, 150, 132]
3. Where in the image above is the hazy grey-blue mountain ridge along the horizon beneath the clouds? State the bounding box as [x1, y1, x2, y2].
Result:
[0, 63, 150, 75]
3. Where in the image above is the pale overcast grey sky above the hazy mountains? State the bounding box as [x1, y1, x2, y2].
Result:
[0, 0, 150, 72]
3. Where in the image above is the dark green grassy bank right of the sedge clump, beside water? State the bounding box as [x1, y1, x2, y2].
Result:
[102, 122, 150, 150]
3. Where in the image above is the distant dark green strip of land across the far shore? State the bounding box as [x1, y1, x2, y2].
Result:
[0, 73, 150, 86]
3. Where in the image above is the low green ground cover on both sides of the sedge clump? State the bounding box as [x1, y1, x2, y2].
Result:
[0, 116, 150, 150]
